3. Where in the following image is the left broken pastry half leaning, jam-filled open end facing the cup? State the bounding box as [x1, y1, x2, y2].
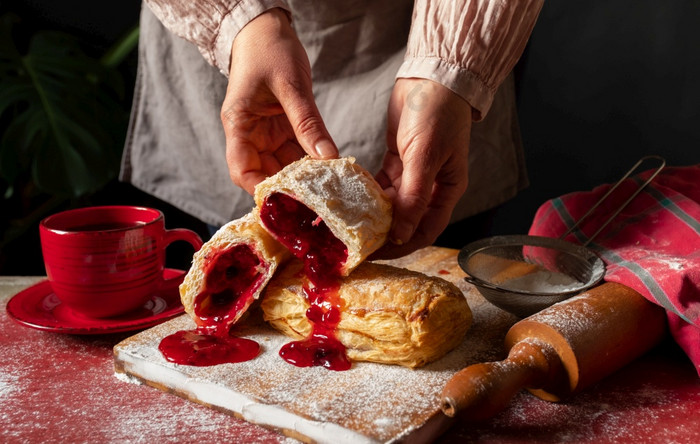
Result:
[180, 211, 291, 333]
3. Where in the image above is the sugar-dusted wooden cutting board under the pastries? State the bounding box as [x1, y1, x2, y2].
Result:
[114, 247, 518, 444]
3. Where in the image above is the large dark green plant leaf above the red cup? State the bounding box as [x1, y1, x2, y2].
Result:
[0, 16, 135, 197]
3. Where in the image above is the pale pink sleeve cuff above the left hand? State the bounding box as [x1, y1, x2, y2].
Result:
[145, 0, 289, 75]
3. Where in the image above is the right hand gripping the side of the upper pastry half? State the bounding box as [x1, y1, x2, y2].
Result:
[373, 79, 472, 258]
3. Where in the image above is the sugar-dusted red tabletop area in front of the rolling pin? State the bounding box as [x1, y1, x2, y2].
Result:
[447, 366, 700, 444]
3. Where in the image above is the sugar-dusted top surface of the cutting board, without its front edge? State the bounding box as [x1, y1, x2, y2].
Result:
[117, 255, 517, 441]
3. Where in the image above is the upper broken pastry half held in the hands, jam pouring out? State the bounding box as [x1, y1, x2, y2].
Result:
[255, 157, 392, 277]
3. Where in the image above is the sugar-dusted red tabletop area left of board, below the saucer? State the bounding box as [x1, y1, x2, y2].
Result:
[0, 278, 296, 443]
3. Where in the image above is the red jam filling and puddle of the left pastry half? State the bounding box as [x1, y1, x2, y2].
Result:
[158, 245, 263, 366]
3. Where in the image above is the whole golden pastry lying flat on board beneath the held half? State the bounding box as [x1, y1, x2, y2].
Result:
[260, 260, 472, 368]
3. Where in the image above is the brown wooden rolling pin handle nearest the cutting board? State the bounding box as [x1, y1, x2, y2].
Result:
[441, 340, 562, 422]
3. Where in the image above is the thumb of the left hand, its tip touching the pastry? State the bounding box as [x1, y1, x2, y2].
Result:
[277, 80, 338, 159]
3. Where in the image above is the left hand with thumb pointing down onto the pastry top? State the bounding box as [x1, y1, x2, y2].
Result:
[221, 8, 338, 194]
